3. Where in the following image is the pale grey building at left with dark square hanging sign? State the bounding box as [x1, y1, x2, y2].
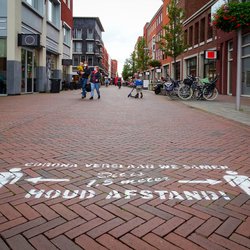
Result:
[0, 0, 72, 95]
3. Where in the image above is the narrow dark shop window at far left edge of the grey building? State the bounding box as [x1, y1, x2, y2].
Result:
[0, 39, 7, 95]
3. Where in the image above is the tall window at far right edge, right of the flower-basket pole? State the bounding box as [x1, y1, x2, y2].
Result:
[242, 34, 250, 95]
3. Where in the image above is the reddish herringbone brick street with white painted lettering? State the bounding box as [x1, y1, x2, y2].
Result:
[0, 86, 250, 250]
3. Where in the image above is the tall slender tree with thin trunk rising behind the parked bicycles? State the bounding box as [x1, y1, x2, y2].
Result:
[159, 0, 187, 78]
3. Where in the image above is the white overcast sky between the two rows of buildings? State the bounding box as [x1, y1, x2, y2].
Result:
[73, 0, 162, 75]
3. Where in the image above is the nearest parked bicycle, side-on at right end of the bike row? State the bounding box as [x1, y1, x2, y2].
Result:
[178, 75, 218, 101]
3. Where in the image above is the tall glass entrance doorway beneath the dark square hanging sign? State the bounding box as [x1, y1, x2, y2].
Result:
[21, 49, 36, 93]
